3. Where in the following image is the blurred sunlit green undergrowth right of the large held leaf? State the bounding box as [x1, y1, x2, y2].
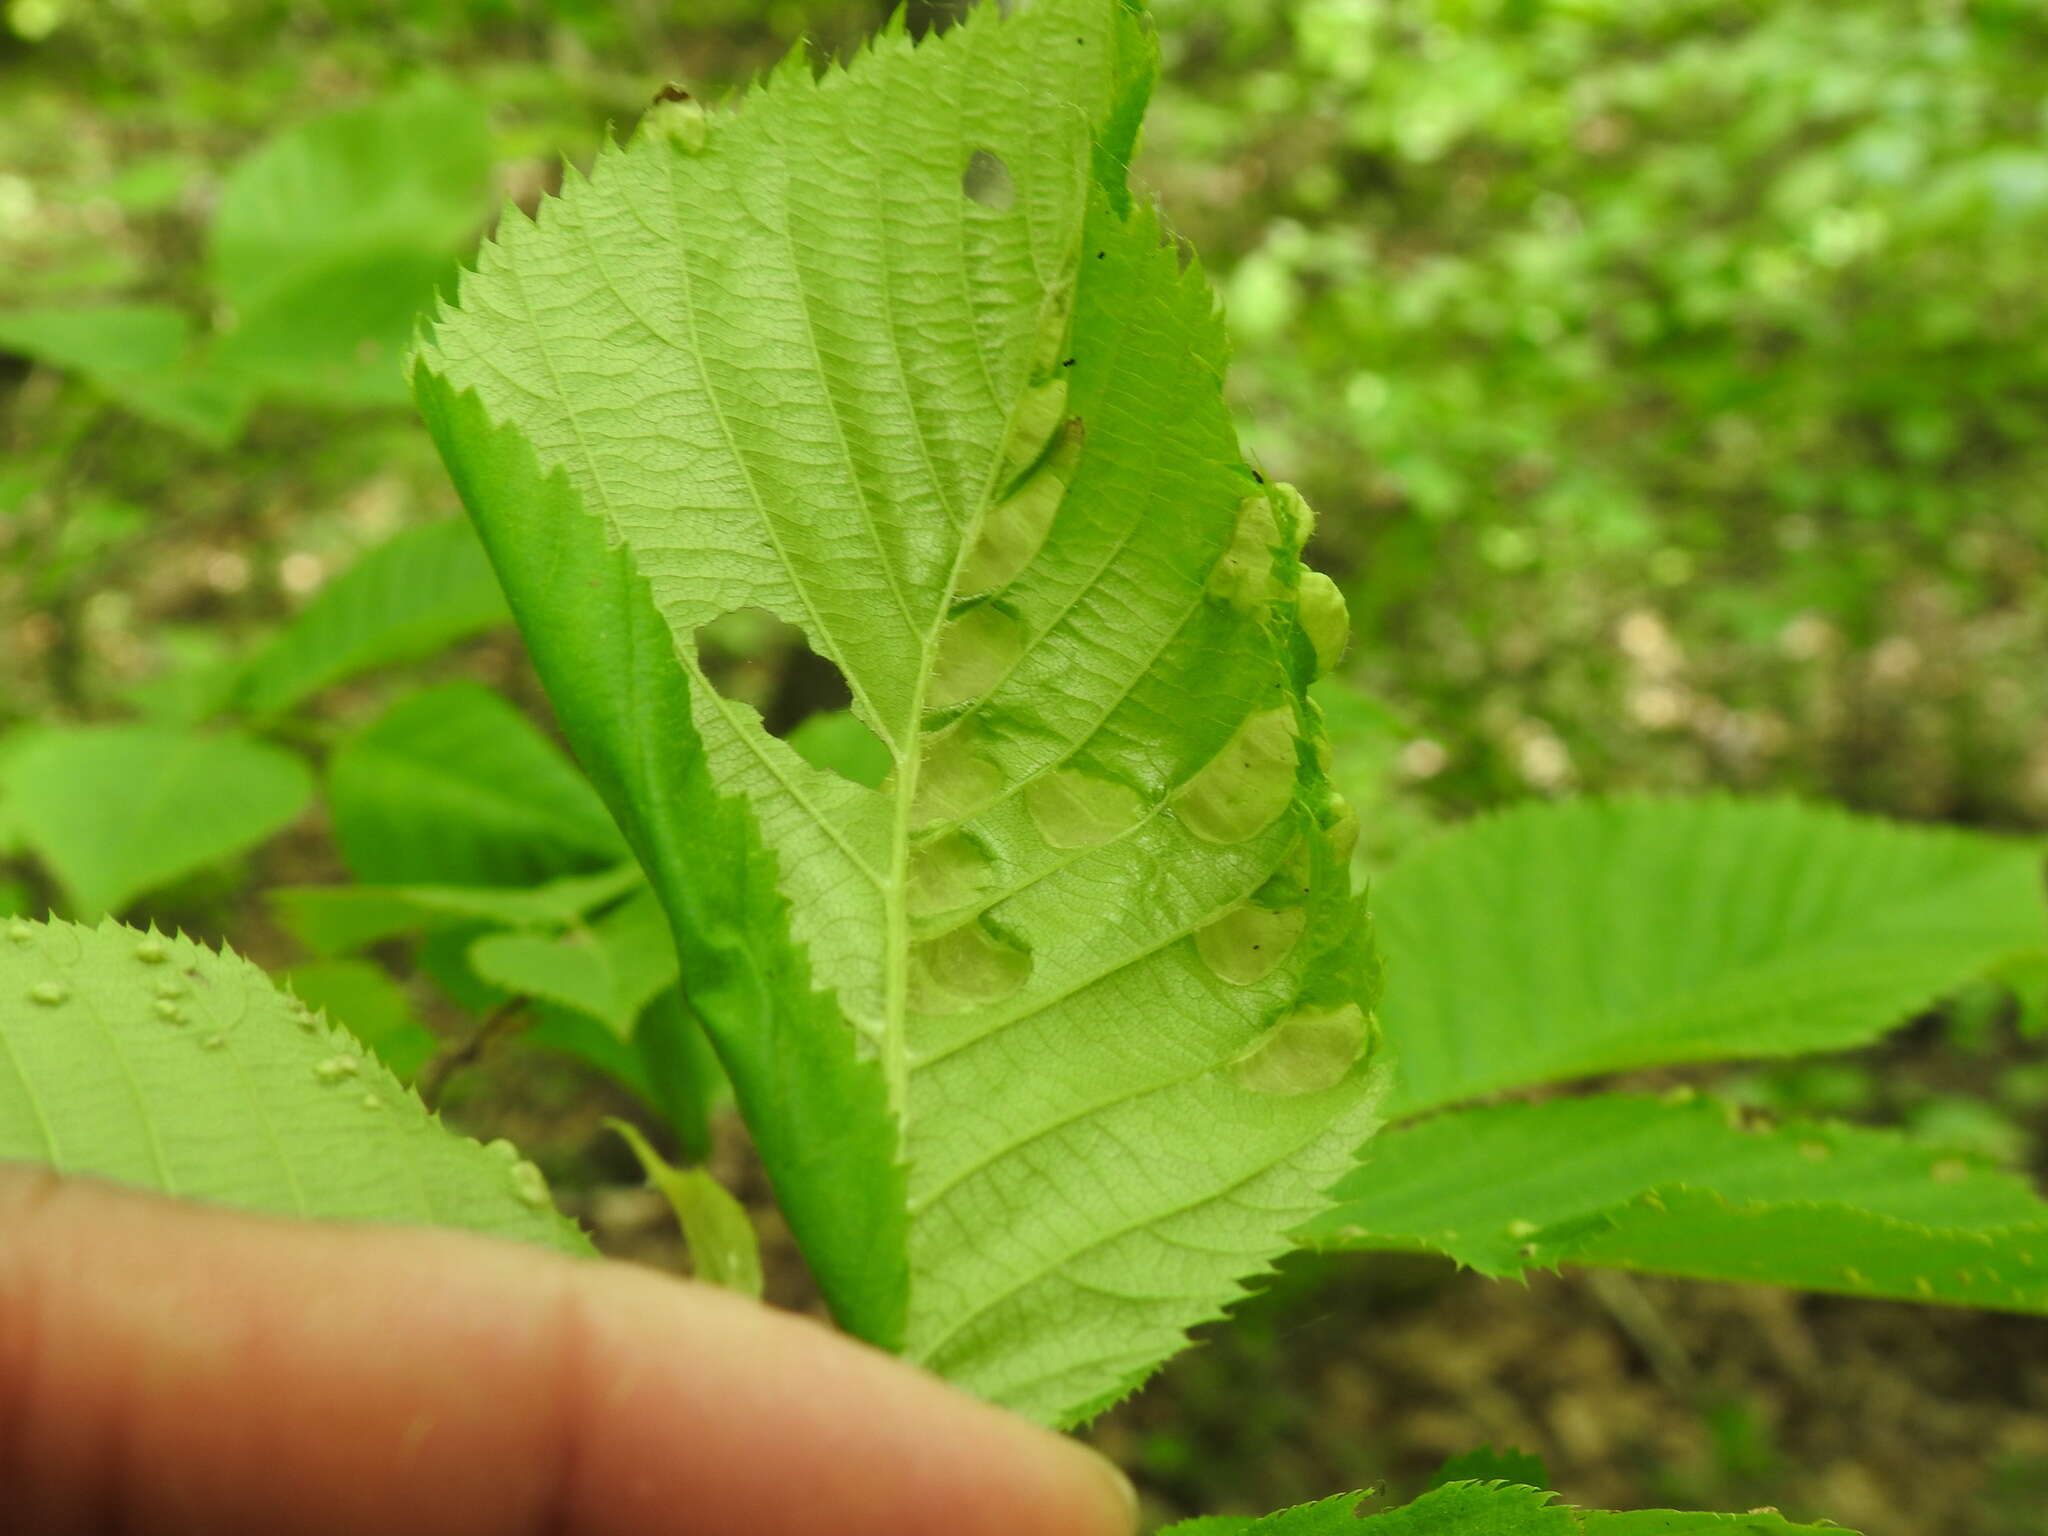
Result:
[1151, 0, 2048, 819]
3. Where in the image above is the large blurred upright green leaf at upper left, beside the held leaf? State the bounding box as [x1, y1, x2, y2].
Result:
[211, 80, 492, 406]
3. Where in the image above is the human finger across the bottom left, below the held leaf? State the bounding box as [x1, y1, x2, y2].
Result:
[0, 1167, 1133, 1536]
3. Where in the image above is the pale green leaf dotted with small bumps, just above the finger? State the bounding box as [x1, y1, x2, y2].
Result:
[0, 920, 590, 1253]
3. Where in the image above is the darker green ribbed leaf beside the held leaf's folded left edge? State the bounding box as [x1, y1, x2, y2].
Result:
[328, 682, 625, 885]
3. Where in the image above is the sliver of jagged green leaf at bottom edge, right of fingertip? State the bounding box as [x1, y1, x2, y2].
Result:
[1161, 1483, 1855, 1536]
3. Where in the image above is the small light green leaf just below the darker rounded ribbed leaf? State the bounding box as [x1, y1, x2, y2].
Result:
[469, 889, 676, 1040]
